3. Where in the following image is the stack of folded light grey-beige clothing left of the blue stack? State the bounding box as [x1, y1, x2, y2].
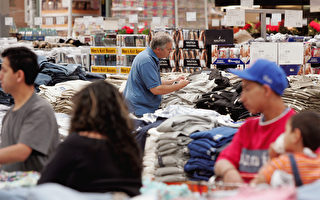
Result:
[155, 115, 217, 182]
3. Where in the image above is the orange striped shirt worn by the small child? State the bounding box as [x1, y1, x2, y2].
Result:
[262, 153, 320, 184]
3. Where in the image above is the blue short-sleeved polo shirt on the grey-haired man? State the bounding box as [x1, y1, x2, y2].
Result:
[123, 47, 161, 116]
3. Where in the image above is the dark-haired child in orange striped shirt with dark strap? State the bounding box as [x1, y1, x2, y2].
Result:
[251, 111, 320, 186]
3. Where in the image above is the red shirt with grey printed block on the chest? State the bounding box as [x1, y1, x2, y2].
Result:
[218, 108, 295, 179]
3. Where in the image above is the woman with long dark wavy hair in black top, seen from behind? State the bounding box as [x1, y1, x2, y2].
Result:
[38, 81, 142, 196]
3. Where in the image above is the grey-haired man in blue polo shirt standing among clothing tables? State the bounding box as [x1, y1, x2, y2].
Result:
[123, 32, 189, 117]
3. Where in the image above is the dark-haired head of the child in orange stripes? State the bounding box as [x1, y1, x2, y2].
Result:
[284, 111, 320, 152]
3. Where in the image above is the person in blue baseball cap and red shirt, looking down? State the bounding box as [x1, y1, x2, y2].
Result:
[214, 59, 295, 183]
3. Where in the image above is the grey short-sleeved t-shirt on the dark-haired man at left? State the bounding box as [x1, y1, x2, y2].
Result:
[0, 93, 59, 171]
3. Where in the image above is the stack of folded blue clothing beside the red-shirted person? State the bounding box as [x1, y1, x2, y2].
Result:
[184, 127, 238, 181]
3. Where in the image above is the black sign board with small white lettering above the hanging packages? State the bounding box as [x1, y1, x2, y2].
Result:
[205, 29, 233, 45]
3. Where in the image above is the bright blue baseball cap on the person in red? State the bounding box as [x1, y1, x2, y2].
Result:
[228, 59, 288, 96]
